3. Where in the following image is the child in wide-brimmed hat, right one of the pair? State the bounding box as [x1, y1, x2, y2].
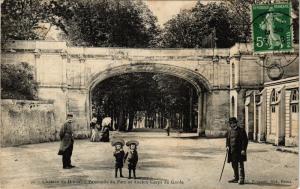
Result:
[124, 140, 139, 179]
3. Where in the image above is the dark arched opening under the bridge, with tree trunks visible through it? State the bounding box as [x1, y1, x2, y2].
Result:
[90, 72, 199, 133]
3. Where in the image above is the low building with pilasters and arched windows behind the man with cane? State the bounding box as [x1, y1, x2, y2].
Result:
[245, 76, 299, 146]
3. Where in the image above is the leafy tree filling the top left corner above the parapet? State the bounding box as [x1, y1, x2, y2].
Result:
[1, 0, 50, 42]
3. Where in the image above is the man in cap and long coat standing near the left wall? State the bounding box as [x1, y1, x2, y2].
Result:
[58, 114, 75, 169]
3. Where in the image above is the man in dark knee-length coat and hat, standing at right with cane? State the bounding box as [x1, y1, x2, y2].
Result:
[226, 117, 248, 184]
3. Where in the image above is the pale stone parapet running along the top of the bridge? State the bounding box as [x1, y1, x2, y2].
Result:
[2, 40, 230, 57]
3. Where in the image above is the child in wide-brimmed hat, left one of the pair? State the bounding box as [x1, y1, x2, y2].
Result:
[112, 139, 125, 178]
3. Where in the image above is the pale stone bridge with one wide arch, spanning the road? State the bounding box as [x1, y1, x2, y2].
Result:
[2, 41, 230, 136]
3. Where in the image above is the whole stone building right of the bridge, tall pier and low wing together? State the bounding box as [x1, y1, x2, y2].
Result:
[230, 45, 299, 146]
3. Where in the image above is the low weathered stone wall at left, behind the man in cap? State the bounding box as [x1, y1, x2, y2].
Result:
[0, 100, 59, 147]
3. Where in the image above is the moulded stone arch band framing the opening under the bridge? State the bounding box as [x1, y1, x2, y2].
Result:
[86, 63, 211, 135]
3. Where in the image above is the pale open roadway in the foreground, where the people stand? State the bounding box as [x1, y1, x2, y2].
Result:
[0, 132, 298, 189]
